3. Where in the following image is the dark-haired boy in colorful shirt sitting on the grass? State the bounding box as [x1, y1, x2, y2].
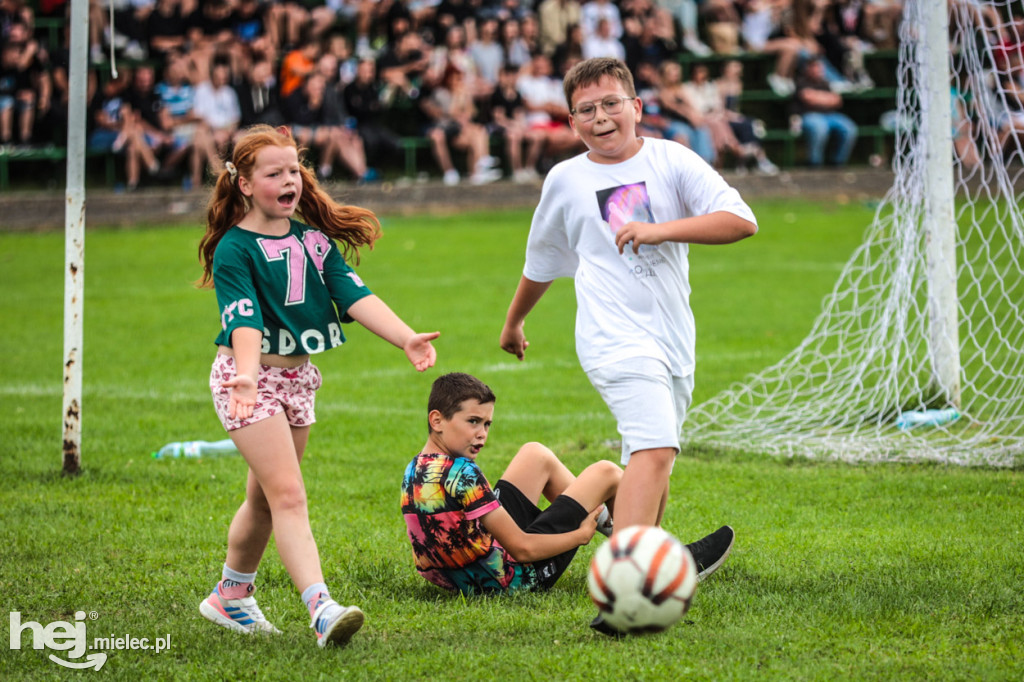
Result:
[401, 373, 623, 594]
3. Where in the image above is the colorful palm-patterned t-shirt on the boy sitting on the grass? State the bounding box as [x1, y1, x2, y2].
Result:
[401, 454, 537, 594]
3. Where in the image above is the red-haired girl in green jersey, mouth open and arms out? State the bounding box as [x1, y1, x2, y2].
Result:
[199, 126, 439, 646]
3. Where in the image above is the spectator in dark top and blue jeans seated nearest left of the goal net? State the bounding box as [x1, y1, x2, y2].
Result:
[794, 53, 857, 167]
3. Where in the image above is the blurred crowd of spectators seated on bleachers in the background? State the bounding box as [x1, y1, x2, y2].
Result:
[0, 0, 991, 188]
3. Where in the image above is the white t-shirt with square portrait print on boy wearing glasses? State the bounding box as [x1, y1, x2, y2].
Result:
[523, 138, 756, 377]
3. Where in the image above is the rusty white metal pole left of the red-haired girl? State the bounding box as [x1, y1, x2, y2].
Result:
[63, 0, 89, 474]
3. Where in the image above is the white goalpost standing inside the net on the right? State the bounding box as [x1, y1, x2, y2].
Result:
[919, 0, 961, 408]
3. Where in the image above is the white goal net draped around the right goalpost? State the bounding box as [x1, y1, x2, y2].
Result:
[683, 0, 1024, 466]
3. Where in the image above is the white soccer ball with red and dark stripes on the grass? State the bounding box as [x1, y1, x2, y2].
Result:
[587, 525, 697, 633]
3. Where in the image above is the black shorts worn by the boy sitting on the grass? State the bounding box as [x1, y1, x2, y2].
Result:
[495, 479, 587, 589]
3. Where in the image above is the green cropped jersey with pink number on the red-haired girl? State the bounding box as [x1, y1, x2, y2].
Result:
[213, 220, 371, 355]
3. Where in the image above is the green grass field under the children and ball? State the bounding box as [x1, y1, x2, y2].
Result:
[0, 202, 1024, 680]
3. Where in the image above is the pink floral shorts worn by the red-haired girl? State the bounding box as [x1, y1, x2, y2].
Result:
[210, 353, 324, 431]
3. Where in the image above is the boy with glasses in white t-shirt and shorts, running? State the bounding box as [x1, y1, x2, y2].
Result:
[501, 57, 757, 634]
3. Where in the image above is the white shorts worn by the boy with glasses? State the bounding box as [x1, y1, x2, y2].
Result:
[587, 357, 693, 466]
